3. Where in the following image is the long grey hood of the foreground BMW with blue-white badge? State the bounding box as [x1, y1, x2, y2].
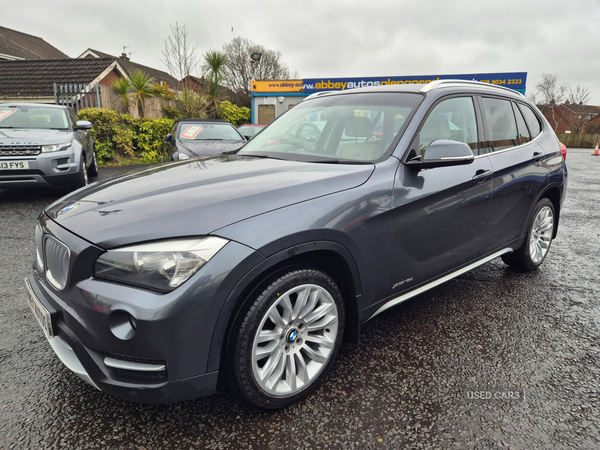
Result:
[46, 155, 375, 248]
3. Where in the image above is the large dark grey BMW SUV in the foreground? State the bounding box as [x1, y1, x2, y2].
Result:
[26, 81, 567, 408]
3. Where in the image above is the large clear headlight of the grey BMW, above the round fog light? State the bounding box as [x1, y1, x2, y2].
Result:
[94, 236, 229, 291]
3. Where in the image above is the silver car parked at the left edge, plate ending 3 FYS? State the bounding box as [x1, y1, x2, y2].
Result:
[0, 103, 98, 189]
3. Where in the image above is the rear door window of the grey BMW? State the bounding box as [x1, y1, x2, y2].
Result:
[482, 97, 519, 151]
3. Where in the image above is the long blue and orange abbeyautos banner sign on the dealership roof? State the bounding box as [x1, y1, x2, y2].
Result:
[252, 72, 527, 95]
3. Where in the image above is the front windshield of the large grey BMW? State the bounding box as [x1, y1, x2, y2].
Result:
[238, 93, 423, 162]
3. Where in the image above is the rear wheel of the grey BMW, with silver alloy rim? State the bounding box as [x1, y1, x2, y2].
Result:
[502, 198, 556, 271]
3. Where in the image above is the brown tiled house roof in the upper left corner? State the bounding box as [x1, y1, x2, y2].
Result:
[0, 27, 69, 61]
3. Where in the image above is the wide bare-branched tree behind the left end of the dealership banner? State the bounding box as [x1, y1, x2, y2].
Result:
[223, 36, 290, 106]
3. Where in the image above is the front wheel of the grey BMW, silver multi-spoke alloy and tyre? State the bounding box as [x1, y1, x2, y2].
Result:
[228, 266, 345, 409]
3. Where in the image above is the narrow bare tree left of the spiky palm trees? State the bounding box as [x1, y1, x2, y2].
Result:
[160, 22, 199, 90]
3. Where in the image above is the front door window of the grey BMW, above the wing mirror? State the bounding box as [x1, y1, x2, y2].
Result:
[419, 97, 479, 155]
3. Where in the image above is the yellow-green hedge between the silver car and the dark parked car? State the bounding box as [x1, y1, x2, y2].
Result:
[78, 108, 173, 164]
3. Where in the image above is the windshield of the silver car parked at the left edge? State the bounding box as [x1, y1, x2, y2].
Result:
[0, 106, 69, 130]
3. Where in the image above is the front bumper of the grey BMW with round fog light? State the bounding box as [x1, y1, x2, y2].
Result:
[25, 216, 254, 403]
